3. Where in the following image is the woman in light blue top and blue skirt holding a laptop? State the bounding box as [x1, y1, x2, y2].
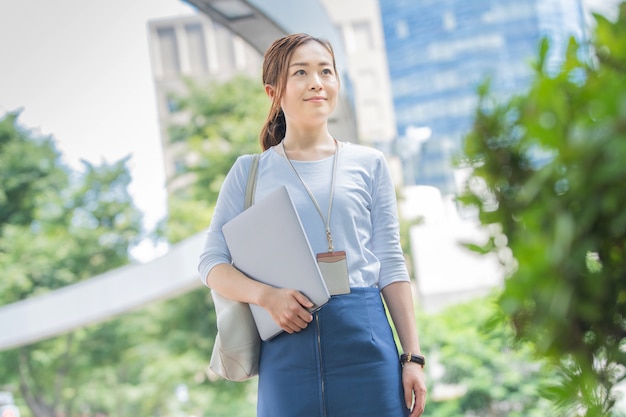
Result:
[199, 34, 426, 417]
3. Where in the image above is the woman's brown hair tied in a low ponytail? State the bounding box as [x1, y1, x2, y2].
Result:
[260, 33, 337, 150]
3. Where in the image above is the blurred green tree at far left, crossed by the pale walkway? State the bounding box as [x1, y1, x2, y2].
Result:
[0, 114, 141, 417]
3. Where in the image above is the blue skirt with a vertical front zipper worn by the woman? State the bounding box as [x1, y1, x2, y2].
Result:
[257, 288, 409, 417]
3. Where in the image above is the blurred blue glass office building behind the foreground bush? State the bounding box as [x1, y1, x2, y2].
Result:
[380, 0, 584, 194]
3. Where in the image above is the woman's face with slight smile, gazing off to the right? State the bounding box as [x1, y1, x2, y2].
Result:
[266, 41, 339, 127]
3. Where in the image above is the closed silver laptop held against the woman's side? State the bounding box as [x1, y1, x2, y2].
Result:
[222, 186, 330, 340]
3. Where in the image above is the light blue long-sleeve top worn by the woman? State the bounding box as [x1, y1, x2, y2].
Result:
[198, 142, 409, 289]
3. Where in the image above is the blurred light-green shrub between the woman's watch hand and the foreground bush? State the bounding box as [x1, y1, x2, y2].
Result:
[418, 298, 555, 417]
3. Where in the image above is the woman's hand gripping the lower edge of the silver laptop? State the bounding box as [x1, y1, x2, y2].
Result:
[261, 287, 314, 334]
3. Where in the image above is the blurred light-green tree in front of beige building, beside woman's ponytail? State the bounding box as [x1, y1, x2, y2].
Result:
[161, 76, 269, 243]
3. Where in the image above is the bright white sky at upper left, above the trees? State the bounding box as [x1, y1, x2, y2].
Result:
[0, 0, 194, 260]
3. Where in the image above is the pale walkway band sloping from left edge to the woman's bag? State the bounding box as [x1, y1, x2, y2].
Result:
[0, 233, 204, 351]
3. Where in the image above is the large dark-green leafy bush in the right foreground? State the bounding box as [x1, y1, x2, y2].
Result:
[454, 3, 626, 416]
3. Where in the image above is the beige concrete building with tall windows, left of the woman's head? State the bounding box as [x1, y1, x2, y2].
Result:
[148, 14, 261, 192]
